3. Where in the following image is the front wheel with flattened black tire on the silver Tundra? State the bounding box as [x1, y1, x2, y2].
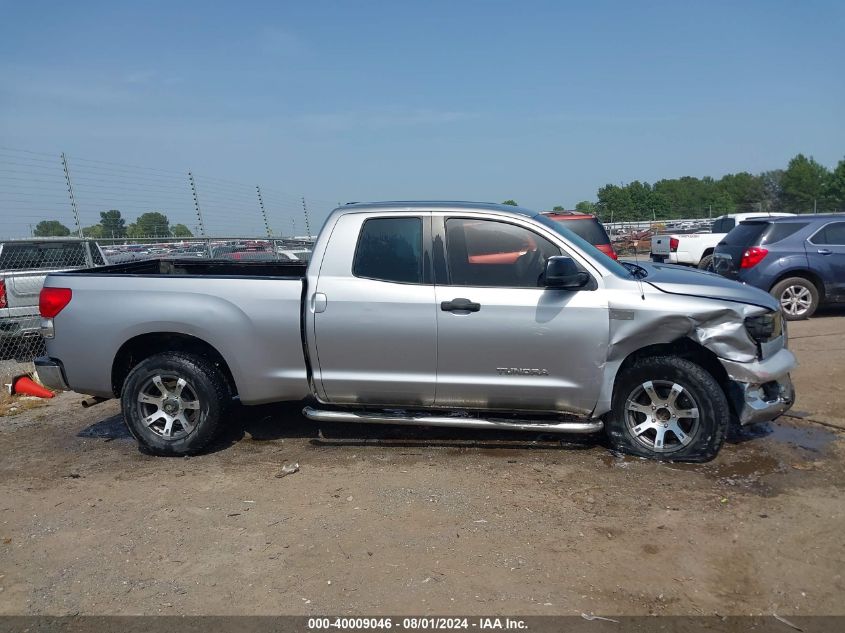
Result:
[605, 356, 731, 462]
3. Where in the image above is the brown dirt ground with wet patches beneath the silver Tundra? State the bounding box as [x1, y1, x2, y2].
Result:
[0, 310, 845, 616]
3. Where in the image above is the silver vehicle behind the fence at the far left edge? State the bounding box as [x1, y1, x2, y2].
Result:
[0, 238, 105, 357]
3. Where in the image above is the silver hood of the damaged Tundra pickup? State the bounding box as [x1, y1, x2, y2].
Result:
[637, 262, 780, 310]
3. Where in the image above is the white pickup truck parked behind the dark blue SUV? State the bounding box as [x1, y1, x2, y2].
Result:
[651, 212, 794, 270]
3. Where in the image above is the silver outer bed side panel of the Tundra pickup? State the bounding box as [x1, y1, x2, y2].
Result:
[45, 258, 310, 404]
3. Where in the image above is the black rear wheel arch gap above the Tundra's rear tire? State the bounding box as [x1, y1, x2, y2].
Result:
[111, 332, 238, 398]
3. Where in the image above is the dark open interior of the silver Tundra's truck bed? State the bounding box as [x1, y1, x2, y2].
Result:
[60, 258, 308, 279]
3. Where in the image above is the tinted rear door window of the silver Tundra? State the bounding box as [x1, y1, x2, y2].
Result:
[352, 218, 423, 284]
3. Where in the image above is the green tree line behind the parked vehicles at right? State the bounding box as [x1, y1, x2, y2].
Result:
[504, 154, 845, 222]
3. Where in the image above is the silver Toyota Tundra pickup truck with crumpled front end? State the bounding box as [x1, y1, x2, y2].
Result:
[36, 202, 796, 461]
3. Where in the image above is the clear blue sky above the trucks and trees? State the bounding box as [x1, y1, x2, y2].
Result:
[0, 0, 845, 232]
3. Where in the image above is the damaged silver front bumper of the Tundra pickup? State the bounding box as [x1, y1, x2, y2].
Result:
[719, 348, 798, 424]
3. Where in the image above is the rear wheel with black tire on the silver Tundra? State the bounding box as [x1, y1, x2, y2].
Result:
[120, 352, 232, 455]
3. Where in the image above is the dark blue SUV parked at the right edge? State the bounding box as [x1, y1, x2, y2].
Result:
[713, 214, 845, 321]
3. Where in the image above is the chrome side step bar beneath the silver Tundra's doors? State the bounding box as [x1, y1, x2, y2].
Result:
[302, 407, 604, 433]
